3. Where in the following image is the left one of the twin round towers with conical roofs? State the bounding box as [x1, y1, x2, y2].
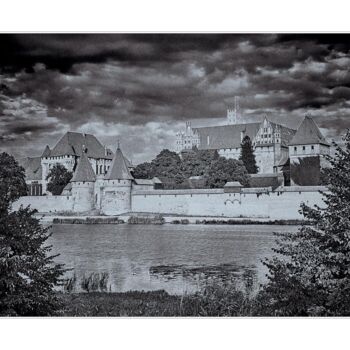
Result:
[71, 150, 96, 212]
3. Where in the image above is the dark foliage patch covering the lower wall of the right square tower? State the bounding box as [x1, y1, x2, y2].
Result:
[290, 157, 321, 186]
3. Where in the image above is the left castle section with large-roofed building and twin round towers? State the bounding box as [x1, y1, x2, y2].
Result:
[20, 132, 160, 215]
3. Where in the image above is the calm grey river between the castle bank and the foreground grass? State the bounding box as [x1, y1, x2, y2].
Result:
[49, 224, 297, 294]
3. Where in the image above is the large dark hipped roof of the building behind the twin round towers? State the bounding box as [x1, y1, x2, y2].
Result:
[50, 131, 113, 159]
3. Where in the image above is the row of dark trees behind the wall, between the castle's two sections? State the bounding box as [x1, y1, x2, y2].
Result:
[133, 139, 258, 189]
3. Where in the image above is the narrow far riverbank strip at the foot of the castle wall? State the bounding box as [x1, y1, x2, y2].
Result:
[37, 214, 305, 225]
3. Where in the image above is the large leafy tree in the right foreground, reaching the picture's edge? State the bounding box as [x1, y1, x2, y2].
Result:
[260, 131, 350, 316]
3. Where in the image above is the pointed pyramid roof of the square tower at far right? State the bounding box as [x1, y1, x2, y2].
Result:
[289, 116, 329, 146]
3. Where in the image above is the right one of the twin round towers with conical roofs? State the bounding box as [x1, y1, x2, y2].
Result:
[101, 142, 133, 215]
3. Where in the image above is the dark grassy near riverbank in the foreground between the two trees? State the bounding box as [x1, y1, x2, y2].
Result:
[59, 288, 254, 317]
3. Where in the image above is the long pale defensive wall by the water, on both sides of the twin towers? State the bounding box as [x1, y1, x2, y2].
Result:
[13, 186, 326, 220]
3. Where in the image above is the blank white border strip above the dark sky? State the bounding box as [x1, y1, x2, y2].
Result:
[0, 0, 350, 32]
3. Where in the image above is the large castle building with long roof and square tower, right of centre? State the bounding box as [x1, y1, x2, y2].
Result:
[176, 109, 330, 174]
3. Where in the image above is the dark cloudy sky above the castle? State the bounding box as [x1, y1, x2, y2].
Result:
[0, 34, 350, 164]
